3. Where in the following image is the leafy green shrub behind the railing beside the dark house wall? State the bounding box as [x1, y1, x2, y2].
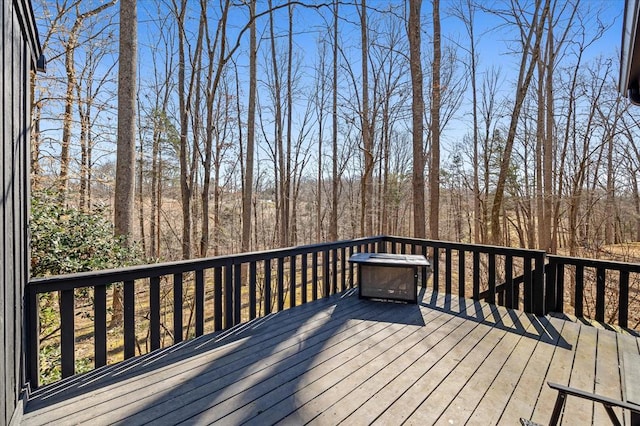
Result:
[30, 192, 143, 384]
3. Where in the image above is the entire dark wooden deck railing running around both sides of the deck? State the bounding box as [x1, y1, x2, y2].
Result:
[25, 236, 640, 388]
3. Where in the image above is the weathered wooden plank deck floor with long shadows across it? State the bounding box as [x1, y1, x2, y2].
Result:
[22, 290, 640, 425]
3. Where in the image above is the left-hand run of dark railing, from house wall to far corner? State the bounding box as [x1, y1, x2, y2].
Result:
[26, 237, 383, 388]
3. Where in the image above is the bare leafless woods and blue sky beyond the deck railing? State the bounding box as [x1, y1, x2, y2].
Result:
[31, 0, 640, 270]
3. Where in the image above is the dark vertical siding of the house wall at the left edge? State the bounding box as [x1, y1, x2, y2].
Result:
[0, 0, 40, 424]
